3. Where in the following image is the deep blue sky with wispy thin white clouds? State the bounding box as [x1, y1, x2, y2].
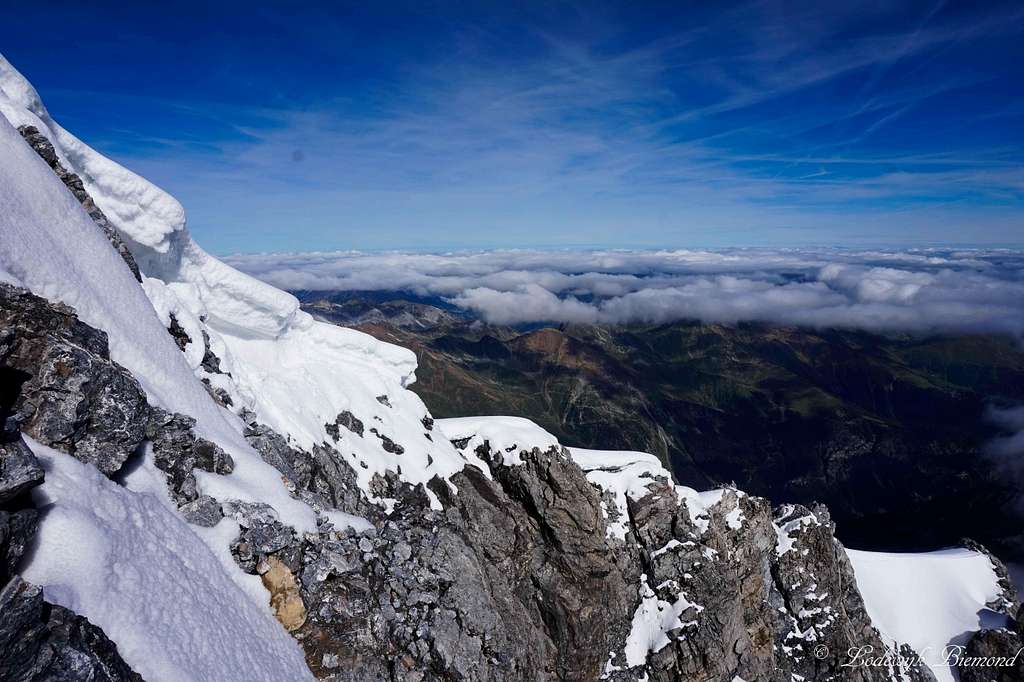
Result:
[0, 1, 1024, 253]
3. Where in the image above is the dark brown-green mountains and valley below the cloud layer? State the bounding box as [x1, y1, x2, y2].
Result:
[295, 292, 1024, 550]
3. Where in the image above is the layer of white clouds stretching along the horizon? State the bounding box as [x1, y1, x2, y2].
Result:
[225, 249, 1024, 338]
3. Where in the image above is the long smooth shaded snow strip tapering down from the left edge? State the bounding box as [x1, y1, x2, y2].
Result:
[0, 107, 316, 531]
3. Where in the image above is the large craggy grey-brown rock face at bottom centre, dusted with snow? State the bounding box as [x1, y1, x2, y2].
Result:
[245, 436, 931, 682]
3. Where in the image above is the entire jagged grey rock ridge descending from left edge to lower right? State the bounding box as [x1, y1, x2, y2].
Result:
[0, 274, 927, 680]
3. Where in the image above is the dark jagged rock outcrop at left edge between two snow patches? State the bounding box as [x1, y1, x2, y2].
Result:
[0, 284, 148, 475]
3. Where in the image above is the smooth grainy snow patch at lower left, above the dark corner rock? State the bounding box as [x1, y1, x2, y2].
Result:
[24, 439, 312, 682]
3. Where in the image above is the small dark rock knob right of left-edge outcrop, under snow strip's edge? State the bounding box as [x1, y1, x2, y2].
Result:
[145, 408, 234, 504]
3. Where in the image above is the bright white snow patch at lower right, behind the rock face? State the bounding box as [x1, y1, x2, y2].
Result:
[847, 548, 1006, 682]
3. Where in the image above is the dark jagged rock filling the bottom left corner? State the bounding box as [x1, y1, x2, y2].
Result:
[0, 577, 142, 682]
